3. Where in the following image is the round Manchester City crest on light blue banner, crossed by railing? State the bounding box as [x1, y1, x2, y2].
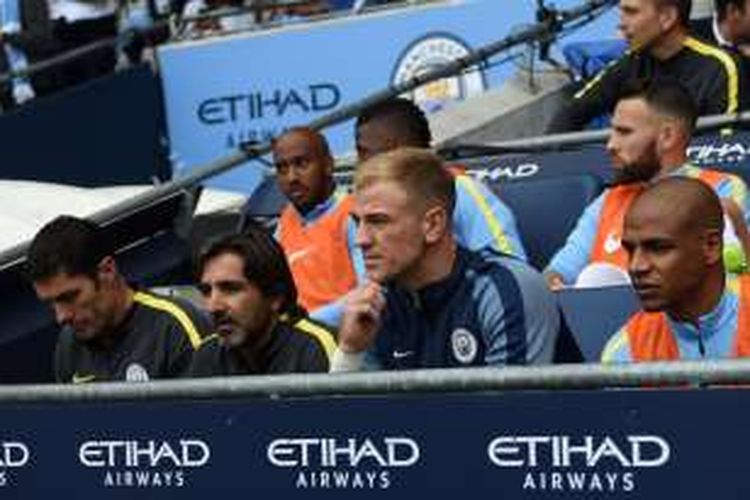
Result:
[392, 33, 486, 112]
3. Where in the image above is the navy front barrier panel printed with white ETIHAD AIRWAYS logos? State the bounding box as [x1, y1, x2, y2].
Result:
[0, 388, 750, 500]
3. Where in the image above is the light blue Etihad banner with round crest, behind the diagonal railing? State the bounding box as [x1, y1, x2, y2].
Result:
[158, 0, 614, 193]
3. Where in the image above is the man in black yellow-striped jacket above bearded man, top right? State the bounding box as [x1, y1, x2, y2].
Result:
[548, 0, 744, 133]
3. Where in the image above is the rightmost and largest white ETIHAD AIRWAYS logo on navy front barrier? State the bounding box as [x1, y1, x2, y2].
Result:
[487, 435, 672, 493]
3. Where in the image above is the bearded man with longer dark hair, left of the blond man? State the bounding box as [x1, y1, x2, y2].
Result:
[190, 227, 335, 377]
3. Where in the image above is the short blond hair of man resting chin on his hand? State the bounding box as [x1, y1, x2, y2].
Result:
[354, 148, 456, 214]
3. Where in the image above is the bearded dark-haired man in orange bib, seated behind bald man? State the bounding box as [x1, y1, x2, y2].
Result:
[545, 80, 750, 289]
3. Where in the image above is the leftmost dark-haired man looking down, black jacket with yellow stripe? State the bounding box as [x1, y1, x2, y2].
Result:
[26, 216, 207, 383]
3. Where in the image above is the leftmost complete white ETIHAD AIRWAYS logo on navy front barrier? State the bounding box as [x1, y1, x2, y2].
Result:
[78, 439, 211, 488]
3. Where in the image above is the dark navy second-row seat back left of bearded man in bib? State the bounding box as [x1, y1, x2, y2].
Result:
[491, 174, 602, 270]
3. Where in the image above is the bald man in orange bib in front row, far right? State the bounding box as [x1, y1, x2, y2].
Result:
[602, 177, 750, 363]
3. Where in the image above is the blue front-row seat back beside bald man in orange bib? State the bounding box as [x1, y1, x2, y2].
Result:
[555, 286, 640, 362]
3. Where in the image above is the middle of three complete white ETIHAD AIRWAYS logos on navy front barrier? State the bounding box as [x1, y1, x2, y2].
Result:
[266, 436, 421, 489]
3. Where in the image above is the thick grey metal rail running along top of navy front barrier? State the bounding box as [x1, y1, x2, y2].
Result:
[0, 360, 750, 403]
